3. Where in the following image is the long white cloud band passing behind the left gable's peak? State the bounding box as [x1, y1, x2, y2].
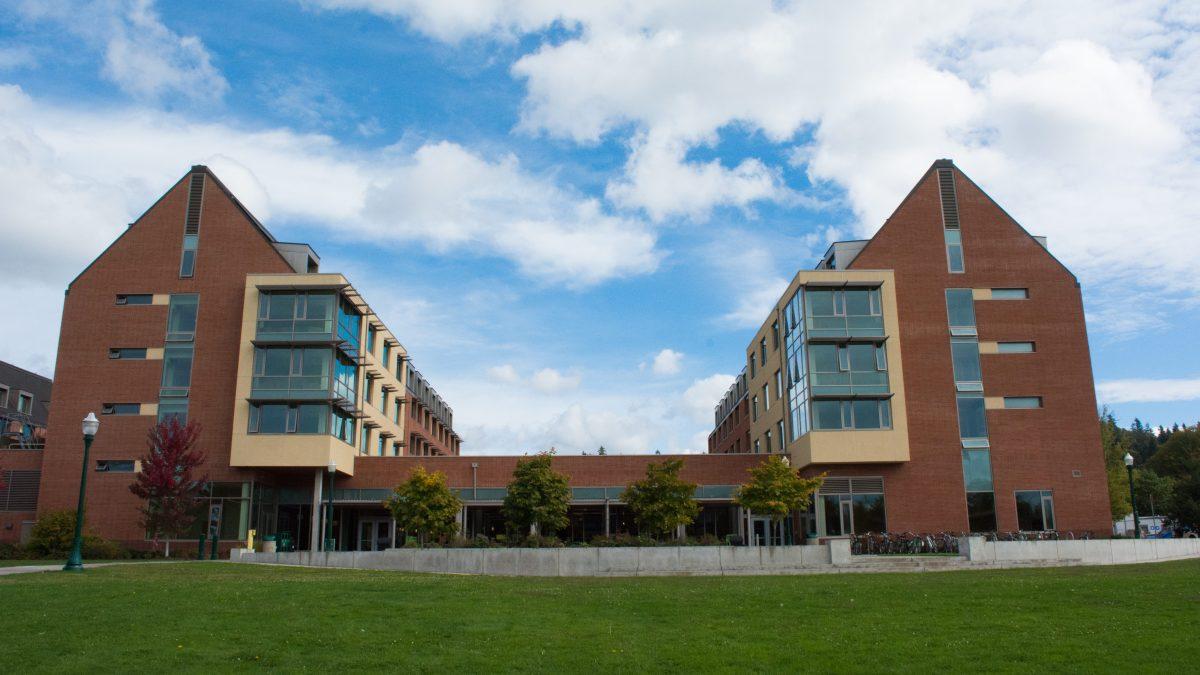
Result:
[0, 85, 660, 287]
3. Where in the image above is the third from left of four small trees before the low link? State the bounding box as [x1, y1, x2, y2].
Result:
[620, 459, 700, 538]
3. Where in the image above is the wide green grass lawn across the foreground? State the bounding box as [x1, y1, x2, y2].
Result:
[0, 561, 1200, 673]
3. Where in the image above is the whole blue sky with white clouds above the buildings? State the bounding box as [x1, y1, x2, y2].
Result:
[0, 0, 1200, 453]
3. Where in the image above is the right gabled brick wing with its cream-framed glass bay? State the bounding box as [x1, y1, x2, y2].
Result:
[709, 160, 1110, 536]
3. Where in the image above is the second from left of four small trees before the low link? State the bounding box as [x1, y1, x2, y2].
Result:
[504, 450, 571, 536]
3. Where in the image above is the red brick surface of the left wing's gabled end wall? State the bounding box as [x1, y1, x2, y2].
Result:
[38, 169, 292, 542]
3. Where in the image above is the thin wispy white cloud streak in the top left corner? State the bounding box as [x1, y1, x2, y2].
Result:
[18, 0, 229, 101]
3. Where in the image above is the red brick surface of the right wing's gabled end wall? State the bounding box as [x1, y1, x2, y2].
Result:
[849, 163, 1111, 534]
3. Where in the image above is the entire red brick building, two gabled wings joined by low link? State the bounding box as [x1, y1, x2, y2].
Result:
[0, 160, 1110, 550]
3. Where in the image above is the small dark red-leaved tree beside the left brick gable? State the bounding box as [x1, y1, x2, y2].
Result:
[130, 416, 208, 557]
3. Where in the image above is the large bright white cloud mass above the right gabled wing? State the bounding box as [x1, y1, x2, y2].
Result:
[334, 0, 1200, 330]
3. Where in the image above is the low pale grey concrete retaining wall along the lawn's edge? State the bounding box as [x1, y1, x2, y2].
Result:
[230, 537, 1200, 577]
